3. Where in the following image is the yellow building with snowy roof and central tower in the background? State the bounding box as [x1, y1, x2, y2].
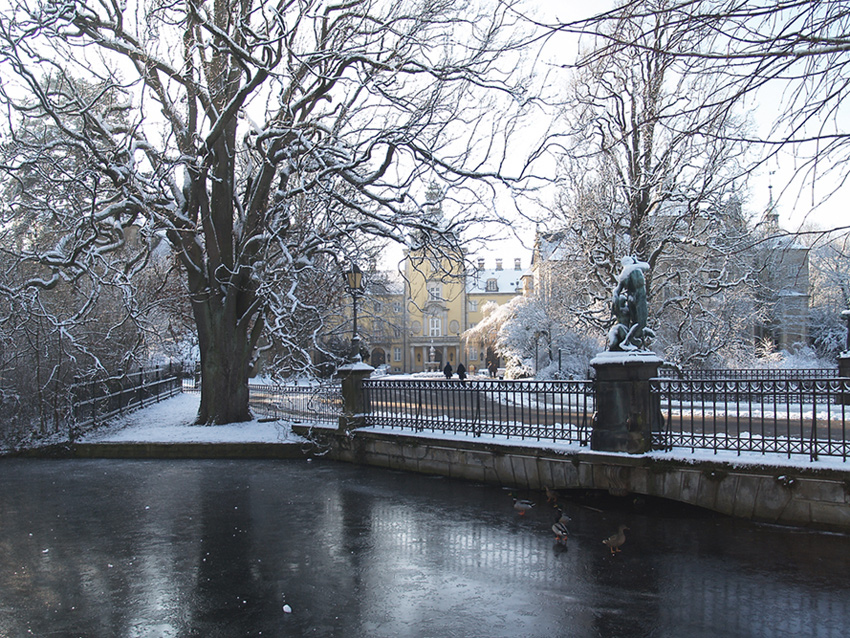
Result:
[361, 251, 527, 373]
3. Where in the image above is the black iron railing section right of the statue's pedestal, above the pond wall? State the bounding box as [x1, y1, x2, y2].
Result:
[651, 377, 850, 461]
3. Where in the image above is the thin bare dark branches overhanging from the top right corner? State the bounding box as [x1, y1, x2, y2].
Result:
[550, 0, 850, 228]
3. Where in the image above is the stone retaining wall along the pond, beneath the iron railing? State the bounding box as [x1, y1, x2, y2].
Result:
[316, 431, 850, 532]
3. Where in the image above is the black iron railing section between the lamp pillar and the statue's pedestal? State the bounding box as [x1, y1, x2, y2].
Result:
[363, 379, 595, 445]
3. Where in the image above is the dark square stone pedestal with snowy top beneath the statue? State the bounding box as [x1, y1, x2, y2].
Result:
[590, 351, 663, 454]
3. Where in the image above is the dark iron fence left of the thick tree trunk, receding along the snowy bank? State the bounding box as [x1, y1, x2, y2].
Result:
[73, 365, 183, 441]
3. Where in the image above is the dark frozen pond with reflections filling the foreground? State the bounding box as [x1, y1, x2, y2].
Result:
[0, 459, 850, 638]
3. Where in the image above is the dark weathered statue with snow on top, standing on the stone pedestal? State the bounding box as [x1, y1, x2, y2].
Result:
[608, 256, 655, 350]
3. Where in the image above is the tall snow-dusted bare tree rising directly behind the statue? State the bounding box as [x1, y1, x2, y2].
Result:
[532, 2, 752, 361]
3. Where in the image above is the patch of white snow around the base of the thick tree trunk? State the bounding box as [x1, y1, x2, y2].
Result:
[79, 393, 303, 443]
